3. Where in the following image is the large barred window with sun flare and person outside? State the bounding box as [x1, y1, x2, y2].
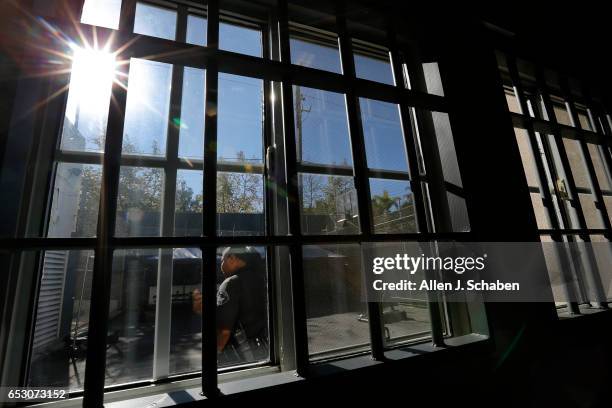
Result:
[3, 0, 486, 404]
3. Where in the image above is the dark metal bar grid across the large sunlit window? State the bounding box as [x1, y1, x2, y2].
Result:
[2, 0, 469, 406]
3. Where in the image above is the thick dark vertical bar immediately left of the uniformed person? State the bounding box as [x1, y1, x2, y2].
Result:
[202, 0, 219, 398]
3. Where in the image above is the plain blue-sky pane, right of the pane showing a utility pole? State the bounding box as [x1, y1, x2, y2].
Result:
[359, 98, 408, 172]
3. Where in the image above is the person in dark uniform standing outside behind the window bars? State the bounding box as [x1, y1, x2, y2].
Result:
[193, 246, 268, 365]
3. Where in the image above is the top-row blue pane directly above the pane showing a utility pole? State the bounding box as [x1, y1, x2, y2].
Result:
[290, 33, 342, 74]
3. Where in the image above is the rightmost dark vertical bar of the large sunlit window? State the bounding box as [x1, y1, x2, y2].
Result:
[388, 34, 444, 347]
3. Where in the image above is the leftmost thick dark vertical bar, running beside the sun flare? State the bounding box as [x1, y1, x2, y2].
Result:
[83, 0, 135, 402]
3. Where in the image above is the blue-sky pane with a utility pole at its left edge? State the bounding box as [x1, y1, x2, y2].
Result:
[293, 86, 353, 167]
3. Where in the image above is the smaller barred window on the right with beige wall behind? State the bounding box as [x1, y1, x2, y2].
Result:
[497, 52, 612, 316]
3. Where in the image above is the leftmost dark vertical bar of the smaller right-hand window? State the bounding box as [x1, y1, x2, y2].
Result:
[507, 55, 580, 314]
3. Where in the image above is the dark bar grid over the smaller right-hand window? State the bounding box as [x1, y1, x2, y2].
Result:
[502, 53, 612, 314]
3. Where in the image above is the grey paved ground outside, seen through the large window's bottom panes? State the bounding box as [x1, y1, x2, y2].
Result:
[31, 304, 429, 389]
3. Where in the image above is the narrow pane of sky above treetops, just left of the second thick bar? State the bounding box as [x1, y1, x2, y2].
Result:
[174, 170, 204, 237]
